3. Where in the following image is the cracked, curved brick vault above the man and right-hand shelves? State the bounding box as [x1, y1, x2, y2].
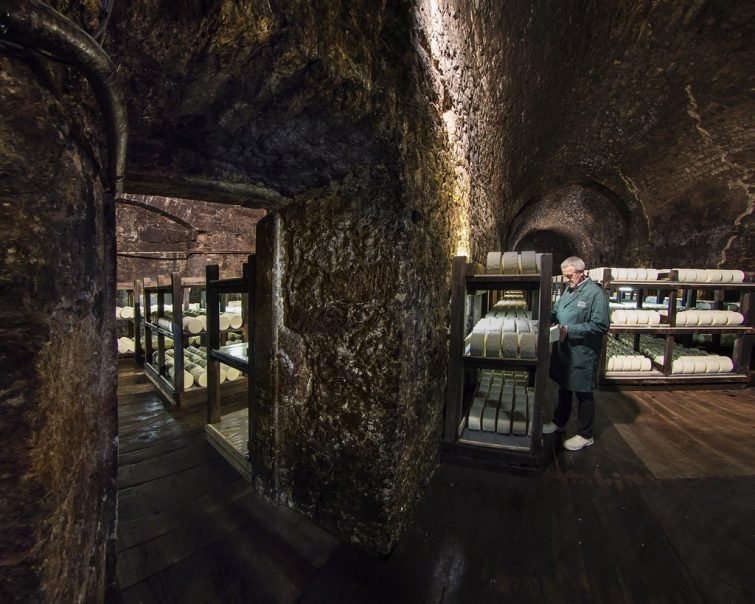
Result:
[418, 0, 755, 268]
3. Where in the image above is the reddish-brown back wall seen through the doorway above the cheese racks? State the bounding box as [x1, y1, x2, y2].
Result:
[116, 194, 265, 283]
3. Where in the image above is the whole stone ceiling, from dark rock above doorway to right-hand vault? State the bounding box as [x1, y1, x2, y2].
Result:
[48, 0, 755, 266]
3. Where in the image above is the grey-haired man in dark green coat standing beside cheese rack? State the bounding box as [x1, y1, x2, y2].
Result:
[543, 256, 609, 451]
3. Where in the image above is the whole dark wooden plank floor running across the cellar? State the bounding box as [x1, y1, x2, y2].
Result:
[117, 364, 755, 604]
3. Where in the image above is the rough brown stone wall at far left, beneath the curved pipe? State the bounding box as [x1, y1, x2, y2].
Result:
[0, 51, 117, 603]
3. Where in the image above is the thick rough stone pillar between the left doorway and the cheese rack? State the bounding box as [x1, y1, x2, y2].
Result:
[239, 2, 468, 553]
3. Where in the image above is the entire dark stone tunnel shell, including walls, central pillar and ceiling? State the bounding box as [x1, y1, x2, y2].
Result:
[0, 0, 755, 601]
